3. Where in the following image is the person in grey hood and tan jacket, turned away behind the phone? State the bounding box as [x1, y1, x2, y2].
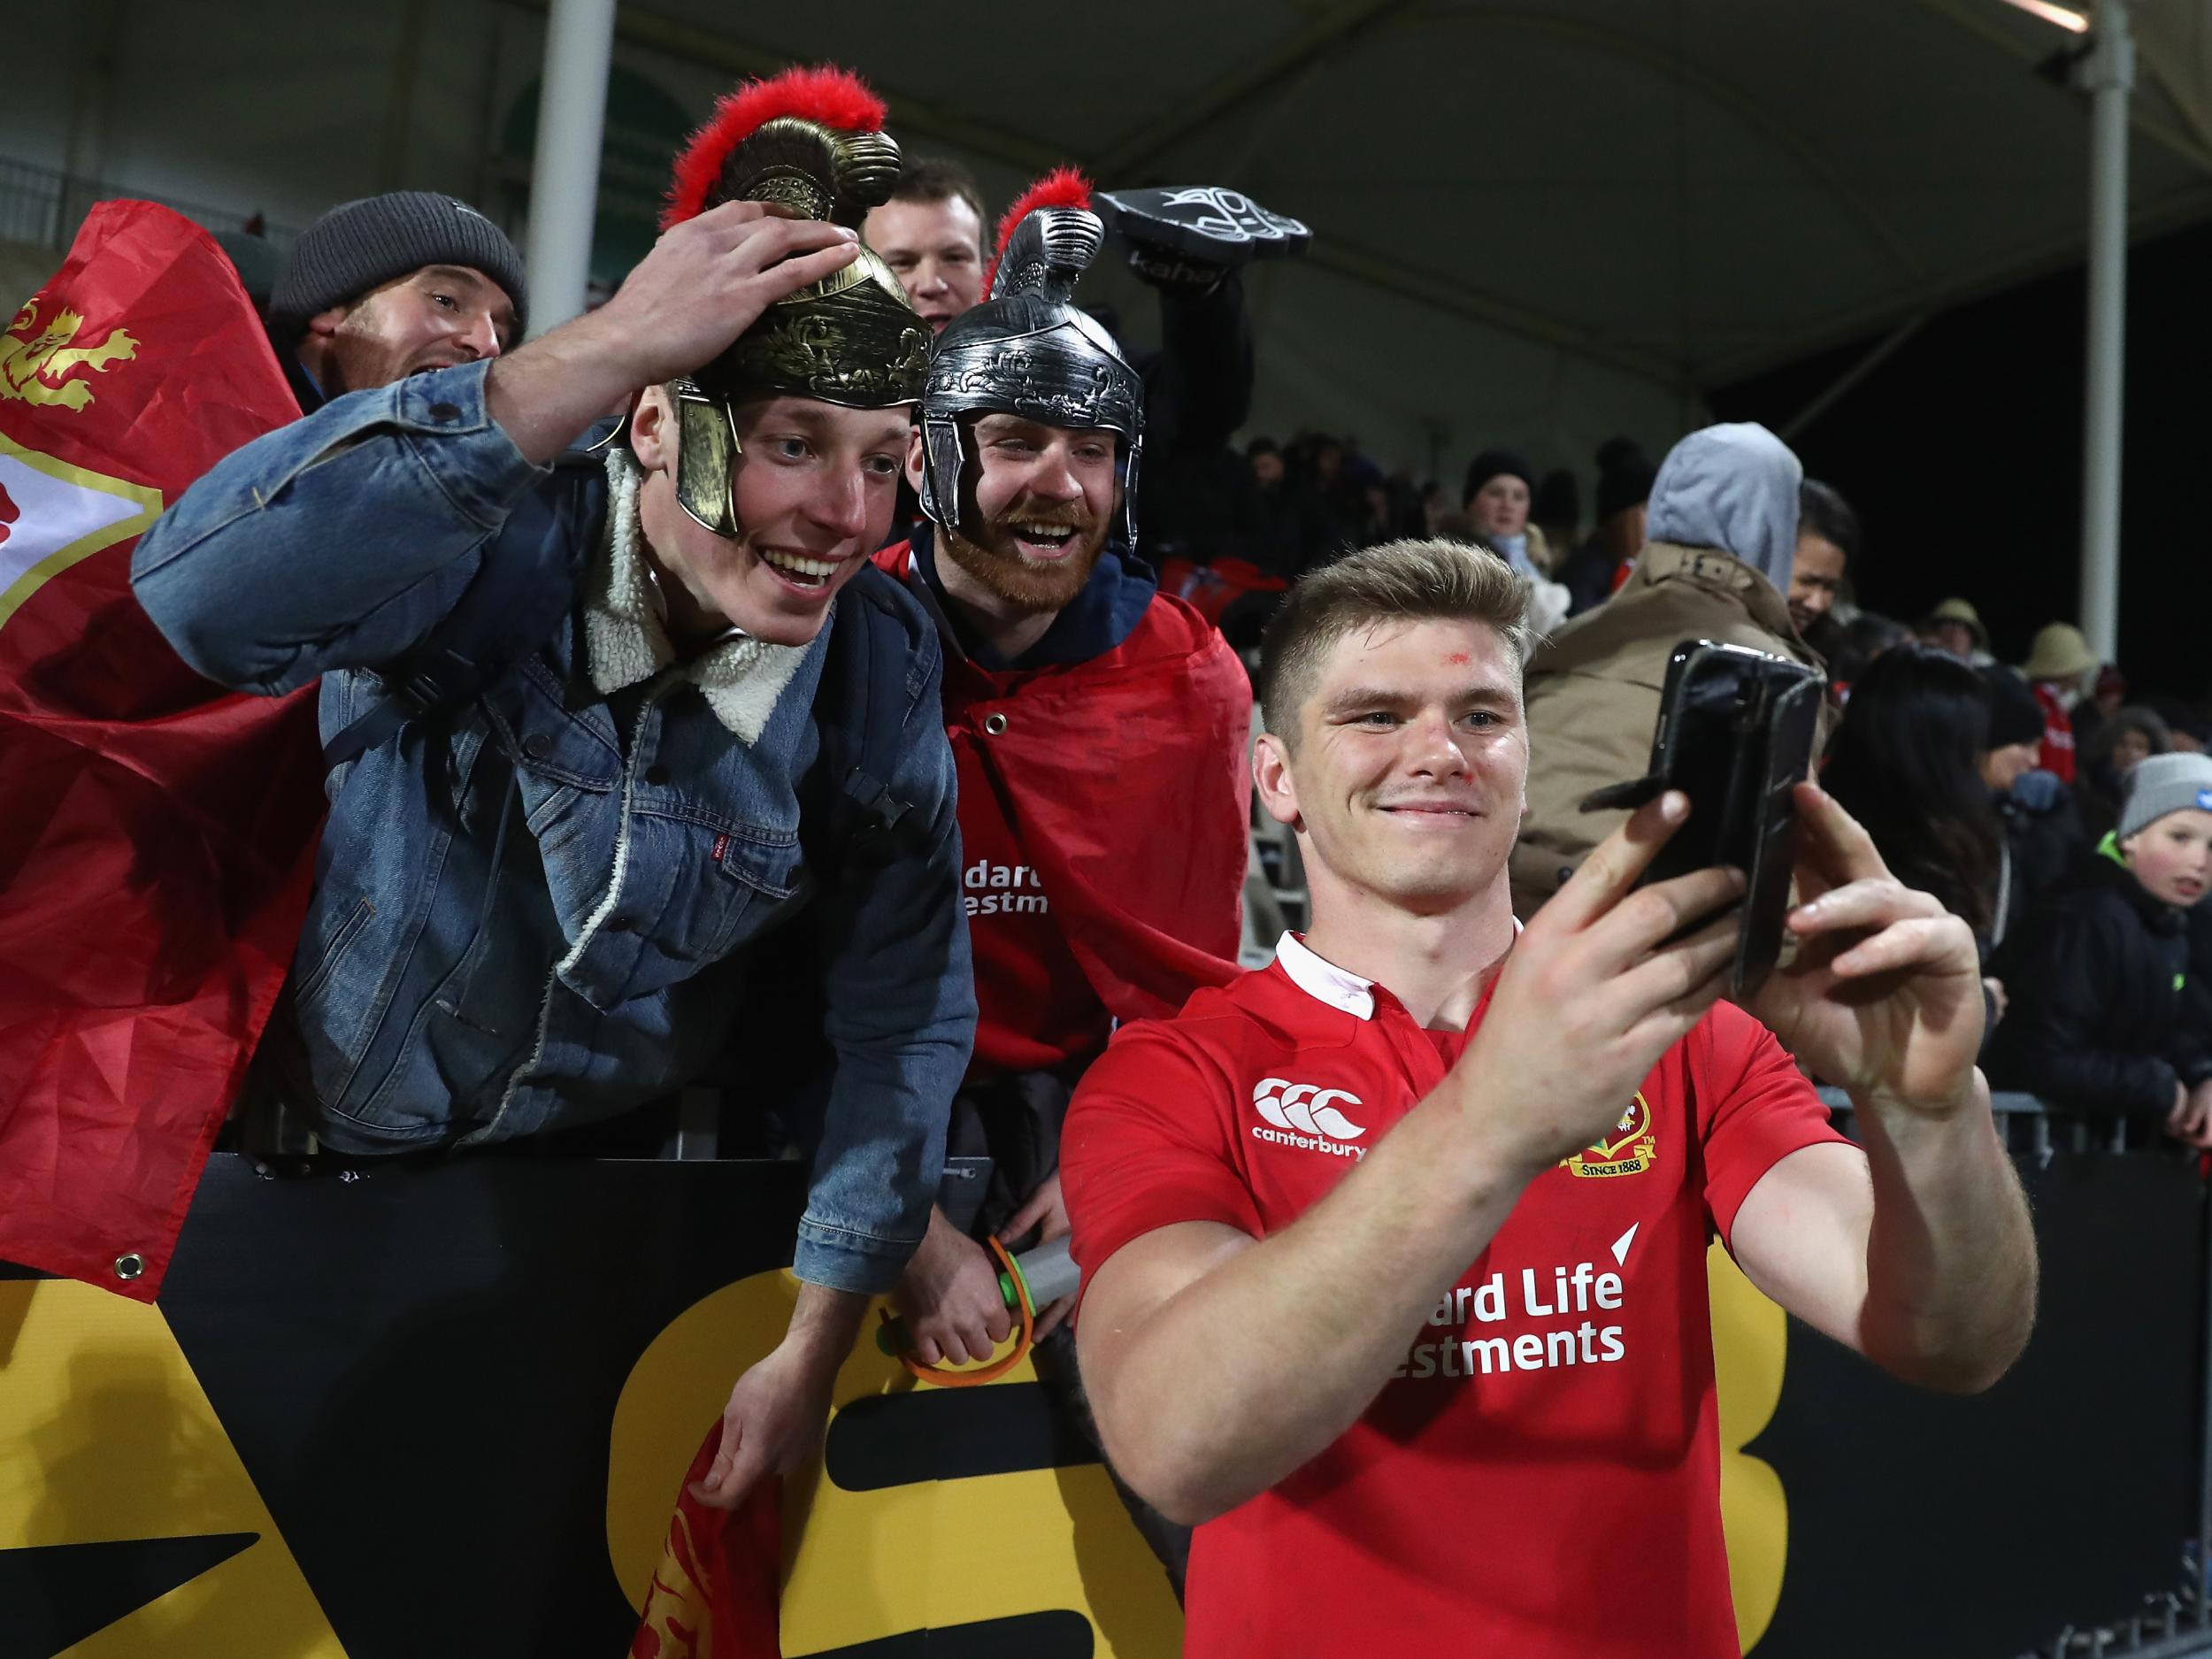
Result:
[1513, 423, 1818, 920]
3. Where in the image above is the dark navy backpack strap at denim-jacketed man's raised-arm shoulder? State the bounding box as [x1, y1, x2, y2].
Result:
[323, 432, 606, 772]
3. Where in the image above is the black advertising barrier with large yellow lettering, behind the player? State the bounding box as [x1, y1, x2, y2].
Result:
[0, 1155, 2206, 1659]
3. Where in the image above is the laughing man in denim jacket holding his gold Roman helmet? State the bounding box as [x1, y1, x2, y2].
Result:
[135, 71, 976, 1504]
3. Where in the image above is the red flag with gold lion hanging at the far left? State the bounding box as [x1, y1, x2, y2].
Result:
[0, 202, 321, 1301]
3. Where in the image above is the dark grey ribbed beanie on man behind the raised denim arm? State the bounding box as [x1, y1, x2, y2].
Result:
[270, 190, 529, 348]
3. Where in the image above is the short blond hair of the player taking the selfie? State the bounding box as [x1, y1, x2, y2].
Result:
[1259, 540, 1533, 743]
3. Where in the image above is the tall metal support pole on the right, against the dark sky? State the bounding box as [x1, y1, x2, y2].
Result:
[2082, 0, 2135, 662]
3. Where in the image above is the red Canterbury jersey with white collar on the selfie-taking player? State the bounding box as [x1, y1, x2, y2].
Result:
[1062, 938, 1843, 1659]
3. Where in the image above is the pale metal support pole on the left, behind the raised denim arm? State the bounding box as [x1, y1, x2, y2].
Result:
[525, 0, 615, 336]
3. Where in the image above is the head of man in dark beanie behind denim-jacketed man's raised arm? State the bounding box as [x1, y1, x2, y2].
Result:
[268, 190, 529, 414]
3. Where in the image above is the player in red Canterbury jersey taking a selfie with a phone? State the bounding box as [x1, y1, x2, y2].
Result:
[1062, 542, 2035, 1659]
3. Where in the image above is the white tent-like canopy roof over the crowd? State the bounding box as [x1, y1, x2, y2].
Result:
[0, 0, 2212, 487]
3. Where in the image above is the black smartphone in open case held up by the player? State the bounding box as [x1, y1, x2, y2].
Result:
[1582, 640, 1825, 1000]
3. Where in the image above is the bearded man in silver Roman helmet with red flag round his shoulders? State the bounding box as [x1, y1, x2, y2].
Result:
[880, 175, 1252, 1566]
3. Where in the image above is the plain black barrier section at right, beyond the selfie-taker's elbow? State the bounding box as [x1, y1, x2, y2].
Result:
[1750, 1153, 2206, 1659]
